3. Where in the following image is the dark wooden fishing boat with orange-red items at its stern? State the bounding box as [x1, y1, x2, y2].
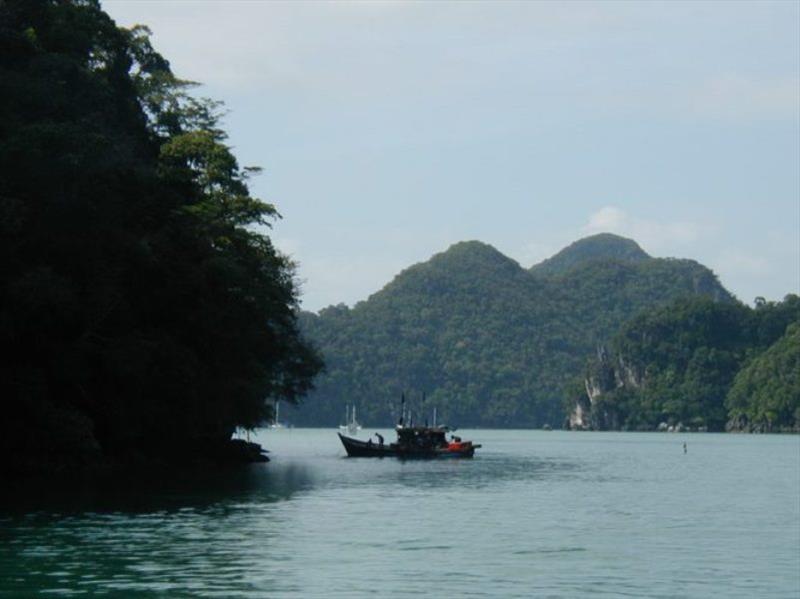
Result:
[339, 424, 481, 458]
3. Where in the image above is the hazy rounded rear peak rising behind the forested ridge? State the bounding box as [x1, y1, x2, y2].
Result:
[530, 233, 650, 275]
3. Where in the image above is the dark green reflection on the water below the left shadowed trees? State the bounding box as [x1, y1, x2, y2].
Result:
[0, 464, 313, 597]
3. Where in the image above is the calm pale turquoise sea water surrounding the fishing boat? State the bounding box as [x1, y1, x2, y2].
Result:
[0, 429, 800, 599]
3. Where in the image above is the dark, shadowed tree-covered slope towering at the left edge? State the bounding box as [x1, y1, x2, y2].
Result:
[0, 0, 320, 472]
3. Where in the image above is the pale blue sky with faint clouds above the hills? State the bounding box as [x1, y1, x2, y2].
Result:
[103, 0, 800, 311]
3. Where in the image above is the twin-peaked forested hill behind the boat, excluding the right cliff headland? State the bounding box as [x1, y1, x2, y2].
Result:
[289, 235, 732, 427]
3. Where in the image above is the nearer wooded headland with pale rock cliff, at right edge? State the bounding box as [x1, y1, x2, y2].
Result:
[582, 295, 800, 430]
